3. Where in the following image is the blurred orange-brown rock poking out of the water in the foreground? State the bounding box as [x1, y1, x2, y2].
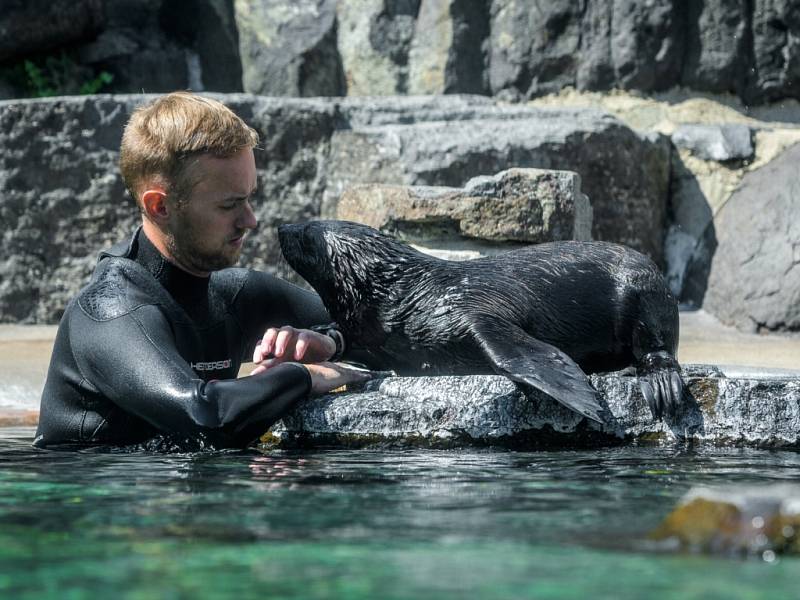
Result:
[650, 485, 800, 561]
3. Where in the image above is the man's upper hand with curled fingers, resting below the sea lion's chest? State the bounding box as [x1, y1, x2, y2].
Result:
[253, 325, 336, 372]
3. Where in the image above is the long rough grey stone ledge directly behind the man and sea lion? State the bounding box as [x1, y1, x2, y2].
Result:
[0, 94, 670, 323]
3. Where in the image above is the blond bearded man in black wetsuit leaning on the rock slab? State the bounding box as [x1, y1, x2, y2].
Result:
[34, 92, 363, 448]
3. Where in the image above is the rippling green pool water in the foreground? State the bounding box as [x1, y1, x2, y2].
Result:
[0, 429, 800, 599]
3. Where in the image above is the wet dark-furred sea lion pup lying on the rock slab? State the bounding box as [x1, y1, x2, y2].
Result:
[278, 221, 683, 423]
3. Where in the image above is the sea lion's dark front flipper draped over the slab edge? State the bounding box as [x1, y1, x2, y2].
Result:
[471, 315, 603, 424]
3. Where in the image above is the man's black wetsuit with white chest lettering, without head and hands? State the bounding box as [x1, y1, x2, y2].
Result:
[34, 230, 329, 448]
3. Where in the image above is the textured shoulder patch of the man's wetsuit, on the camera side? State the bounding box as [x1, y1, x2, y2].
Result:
[73, 256, 161, 321]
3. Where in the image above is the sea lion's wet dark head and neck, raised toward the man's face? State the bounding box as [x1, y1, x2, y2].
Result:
[278, 221, 418, 333]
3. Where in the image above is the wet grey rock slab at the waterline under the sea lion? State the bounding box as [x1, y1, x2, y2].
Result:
[262, 365, 800, 448]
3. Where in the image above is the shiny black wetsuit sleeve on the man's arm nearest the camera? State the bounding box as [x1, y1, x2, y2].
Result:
[71, 305, 311, 447]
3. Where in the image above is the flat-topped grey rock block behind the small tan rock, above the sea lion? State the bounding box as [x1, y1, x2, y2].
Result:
[323, 105, 670, 263]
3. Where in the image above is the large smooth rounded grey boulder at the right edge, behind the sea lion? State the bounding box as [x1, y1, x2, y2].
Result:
[703, 144, 800, 332]
